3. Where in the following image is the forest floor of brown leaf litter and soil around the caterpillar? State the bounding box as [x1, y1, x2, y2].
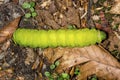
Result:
[0, 0, 120, 80]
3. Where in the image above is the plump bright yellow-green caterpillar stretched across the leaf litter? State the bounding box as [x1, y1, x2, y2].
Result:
[13, 28, 106, 48]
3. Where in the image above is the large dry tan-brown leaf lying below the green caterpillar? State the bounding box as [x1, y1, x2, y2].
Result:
[44, 45, 120, 80]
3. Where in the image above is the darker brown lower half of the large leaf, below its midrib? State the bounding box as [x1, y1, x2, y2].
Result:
[76, 61, 120, 80]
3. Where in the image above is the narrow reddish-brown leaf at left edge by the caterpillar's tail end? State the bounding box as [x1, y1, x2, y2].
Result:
[0, 17, 20, 43]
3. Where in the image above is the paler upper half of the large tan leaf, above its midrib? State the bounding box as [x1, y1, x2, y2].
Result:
[56, 46, 120, 72]
